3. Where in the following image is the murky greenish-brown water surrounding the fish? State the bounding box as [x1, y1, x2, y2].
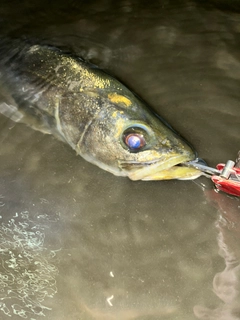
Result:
[0, 0, 240, 320]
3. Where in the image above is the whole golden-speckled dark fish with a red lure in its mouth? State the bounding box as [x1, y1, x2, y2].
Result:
[0, 39, 201, 180]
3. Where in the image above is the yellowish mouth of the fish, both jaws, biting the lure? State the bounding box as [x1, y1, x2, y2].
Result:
[121, 154, 202, 181]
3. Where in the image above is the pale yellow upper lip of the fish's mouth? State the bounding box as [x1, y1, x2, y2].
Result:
[121, 155, 195, 180]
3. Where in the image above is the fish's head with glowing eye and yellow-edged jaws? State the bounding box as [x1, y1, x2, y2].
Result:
[78, 92, 200, 180]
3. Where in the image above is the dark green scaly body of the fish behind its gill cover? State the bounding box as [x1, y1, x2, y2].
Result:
[0, 40, 118, 141]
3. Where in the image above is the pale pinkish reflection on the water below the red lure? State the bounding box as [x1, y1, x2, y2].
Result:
[194, 191, 240, 320]
